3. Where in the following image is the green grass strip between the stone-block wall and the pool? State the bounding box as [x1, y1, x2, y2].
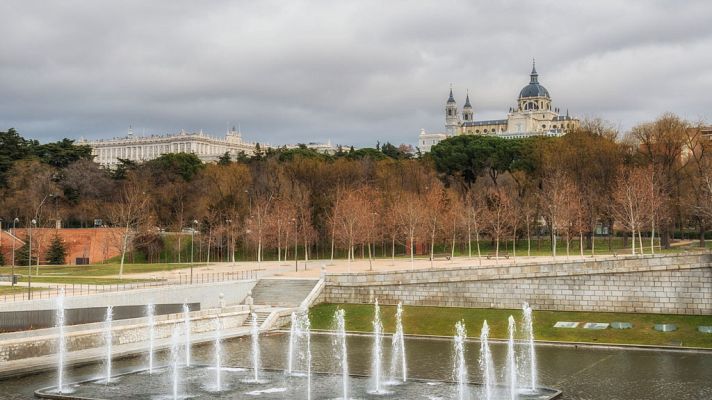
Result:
[310, 304, 712, 348]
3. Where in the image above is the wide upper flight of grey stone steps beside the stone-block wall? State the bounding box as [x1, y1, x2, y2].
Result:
[252, 278, 319, 307]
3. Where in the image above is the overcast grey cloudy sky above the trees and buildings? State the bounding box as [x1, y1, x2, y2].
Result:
[0, 0, 712, 146]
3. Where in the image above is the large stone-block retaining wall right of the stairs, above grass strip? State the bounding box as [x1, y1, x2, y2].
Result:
[320, 253, 712, 315]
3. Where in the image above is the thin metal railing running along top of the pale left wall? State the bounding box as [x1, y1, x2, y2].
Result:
[0, 268, 264, 303]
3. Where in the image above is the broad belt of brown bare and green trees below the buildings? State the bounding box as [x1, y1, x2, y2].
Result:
[0, 114, 712, 263]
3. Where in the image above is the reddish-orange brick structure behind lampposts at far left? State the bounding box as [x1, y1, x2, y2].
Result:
[3, 228, 122, 265]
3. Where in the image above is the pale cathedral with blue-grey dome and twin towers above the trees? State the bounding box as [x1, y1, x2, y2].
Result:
[418, 61, 579, 151]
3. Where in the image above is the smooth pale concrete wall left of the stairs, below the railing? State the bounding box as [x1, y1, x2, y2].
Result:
[0, 280, 256, 312]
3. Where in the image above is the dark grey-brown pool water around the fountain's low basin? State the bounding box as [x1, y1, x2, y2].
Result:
[0, 334, 712, 400]
